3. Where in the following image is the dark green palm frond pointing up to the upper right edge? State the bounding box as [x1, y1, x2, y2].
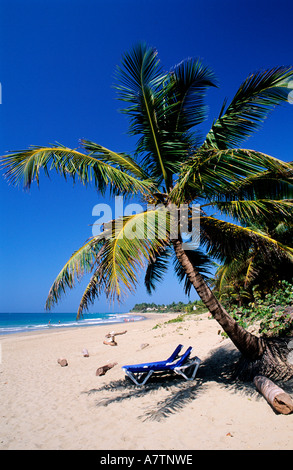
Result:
[204, 66, 293, 149]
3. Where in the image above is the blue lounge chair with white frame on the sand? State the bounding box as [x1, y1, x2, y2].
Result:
[122, 344, 200, 385]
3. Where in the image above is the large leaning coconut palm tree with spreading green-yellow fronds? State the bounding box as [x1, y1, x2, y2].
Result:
[3, 44, 293, 375]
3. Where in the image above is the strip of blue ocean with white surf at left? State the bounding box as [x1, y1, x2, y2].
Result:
[0, 312, 144, 335]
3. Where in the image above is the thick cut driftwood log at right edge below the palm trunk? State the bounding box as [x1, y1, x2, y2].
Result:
[254, 375, 293, 415]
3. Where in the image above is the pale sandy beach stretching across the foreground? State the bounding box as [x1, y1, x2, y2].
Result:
[0, 314, 293, 450]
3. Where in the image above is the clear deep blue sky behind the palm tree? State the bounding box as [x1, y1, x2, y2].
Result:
[0, 0, 293, 312]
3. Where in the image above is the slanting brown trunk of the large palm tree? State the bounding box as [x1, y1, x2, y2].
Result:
[173, 240, 264, 360]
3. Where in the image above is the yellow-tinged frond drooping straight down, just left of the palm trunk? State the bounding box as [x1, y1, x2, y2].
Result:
[78, 207, 170, 315]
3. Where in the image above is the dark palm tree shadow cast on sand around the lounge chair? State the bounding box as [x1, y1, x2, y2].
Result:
[83, 344, 293, 421]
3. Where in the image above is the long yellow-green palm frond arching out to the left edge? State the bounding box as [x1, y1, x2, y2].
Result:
[2, 144, 153, 194]
